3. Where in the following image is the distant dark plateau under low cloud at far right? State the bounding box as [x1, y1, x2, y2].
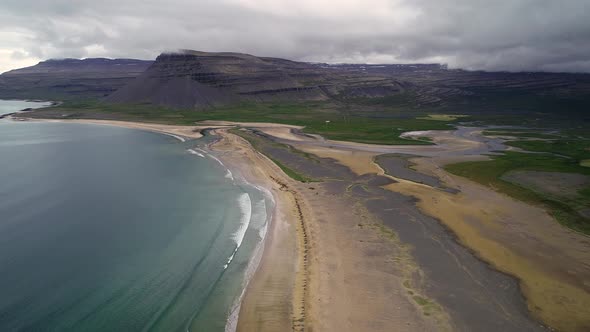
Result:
[340, 64, 590, 104]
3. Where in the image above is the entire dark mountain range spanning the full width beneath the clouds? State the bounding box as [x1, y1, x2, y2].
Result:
[0, 50, 590, 112]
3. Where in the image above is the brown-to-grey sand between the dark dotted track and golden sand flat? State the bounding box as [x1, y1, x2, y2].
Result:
[237, 128, 543, 331]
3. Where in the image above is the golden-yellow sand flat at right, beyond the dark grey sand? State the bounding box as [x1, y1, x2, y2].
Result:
[396, 158, 590, 331]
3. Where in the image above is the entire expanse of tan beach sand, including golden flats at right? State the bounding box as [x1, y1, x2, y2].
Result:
[18, 120, 590, 331]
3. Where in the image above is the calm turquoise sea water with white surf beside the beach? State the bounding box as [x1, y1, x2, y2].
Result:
[0, 100, 272, 331]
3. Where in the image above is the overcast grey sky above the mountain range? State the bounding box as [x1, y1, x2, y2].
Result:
[0, 0, 590, 72]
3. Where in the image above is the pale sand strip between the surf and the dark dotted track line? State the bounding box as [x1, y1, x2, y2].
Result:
[7, 116, 301, 331]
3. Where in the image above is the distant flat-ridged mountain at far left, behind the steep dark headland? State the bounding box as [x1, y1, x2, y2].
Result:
[0, 58, 153, 100]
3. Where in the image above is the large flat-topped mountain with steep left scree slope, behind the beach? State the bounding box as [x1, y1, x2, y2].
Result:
[106, 50, 434, 108]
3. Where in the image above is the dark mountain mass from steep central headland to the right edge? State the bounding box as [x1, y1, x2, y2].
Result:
[106, 50, 590, 109]
